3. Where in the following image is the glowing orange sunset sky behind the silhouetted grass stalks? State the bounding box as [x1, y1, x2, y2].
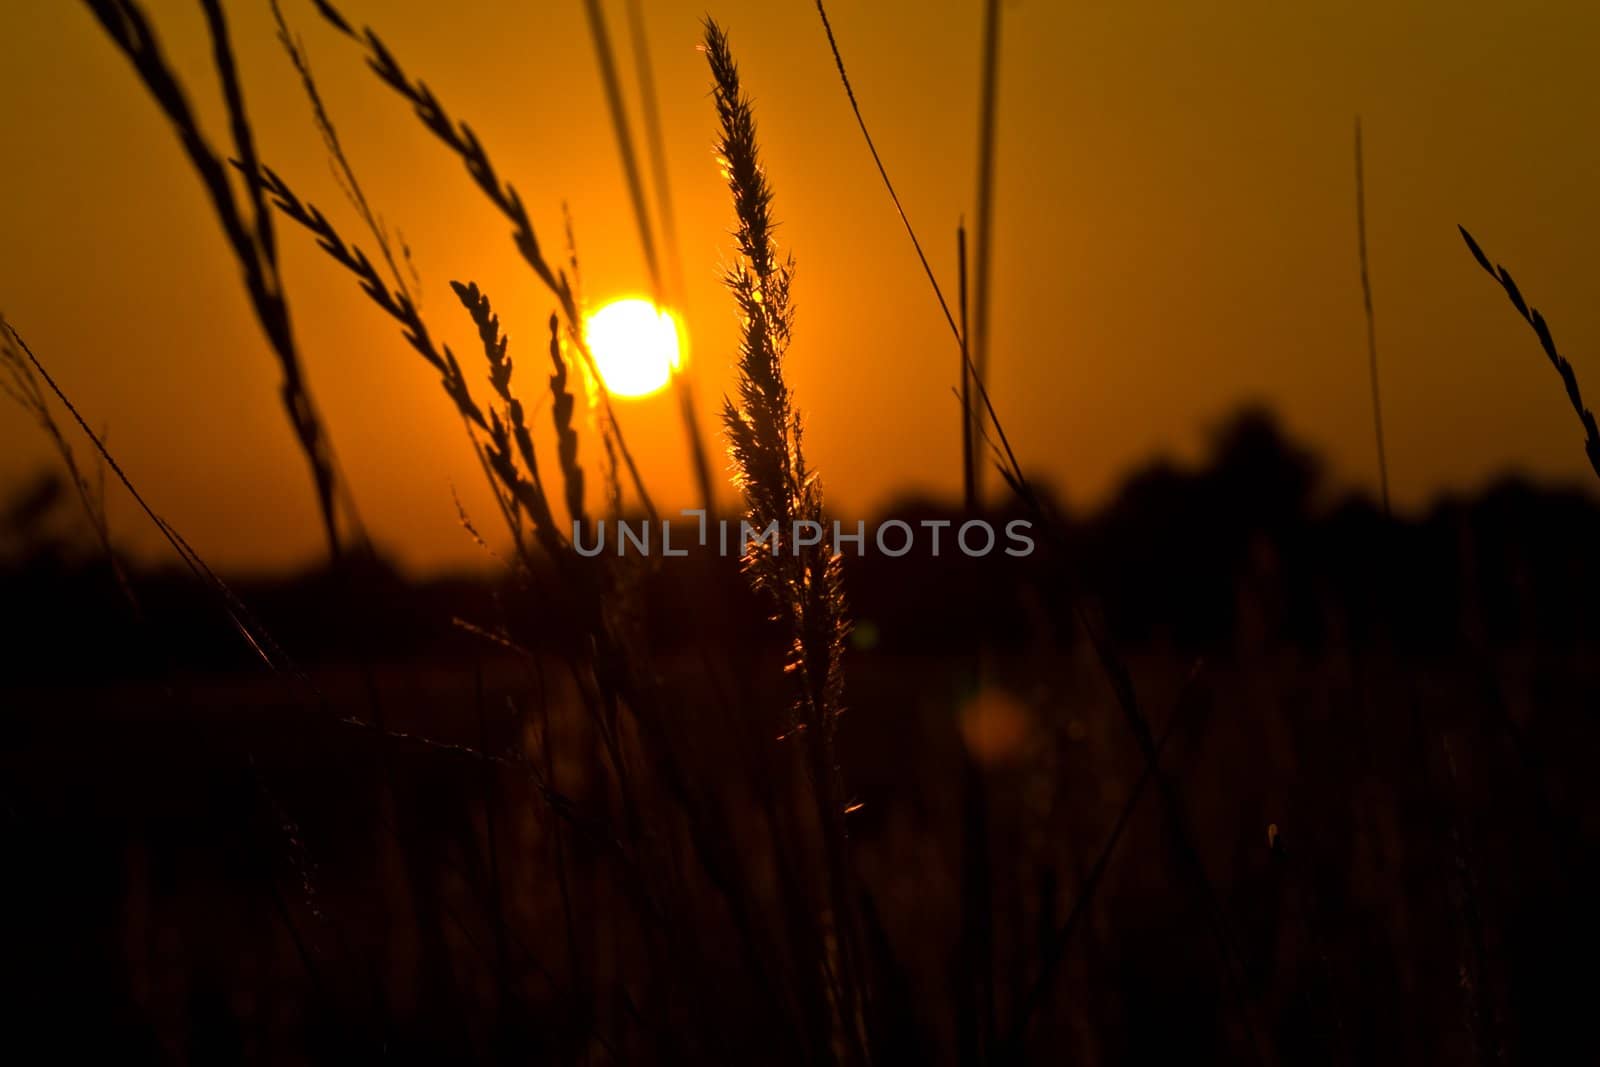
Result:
[0, 0, 1600, 568]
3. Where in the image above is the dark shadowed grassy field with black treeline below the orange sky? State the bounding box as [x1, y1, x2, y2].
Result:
[3, 419, 1600, 1064]
